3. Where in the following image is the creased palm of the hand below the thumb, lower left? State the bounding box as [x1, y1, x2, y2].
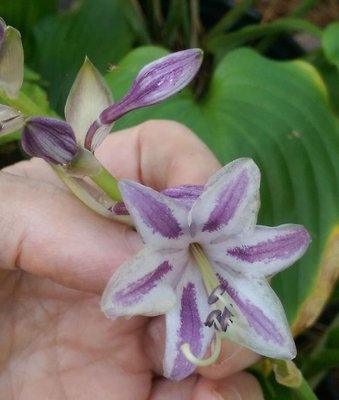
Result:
[0, 272, 152, 400]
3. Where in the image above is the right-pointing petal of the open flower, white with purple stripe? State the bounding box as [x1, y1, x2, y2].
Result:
[216, 224, 310, 276]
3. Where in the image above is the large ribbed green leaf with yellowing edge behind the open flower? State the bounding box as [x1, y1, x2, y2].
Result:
[107, 47, 339, 333]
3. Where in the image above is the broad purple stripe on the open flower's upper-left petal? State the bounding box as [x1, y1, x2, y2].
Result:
[120, 184, 183, 239]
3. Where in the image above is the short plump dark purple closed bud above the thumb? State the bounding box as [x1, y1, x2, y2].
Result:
[21, 117, 78, 164]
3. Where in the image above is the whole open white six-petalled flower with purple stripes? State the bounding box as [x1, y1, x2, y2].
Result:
[101, 159, 310, 380]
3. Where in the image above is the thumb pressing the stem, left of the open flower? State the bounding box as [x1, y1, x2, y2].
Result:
[0, 171, 141, 293]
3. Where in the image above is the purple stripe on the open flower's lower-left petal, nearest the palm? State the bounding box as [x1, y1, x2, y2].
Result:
[114, 261, 173, 306]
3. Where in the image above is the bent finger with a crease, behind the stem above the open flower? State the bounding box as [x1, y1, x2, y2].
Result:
[96, 121, 220, 190]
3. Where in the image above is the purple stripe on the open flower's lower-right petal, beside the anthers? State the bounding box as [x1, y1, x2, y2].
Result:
[218, 275, 285, 345]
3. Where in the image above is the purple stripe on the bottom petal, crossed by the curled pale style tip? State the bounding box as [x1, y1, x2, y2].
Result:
[171, 282, 203, 380]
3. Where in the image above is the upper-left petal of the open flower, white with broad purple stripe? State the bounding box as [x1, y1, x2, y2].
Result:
[119, 180, 188, 248]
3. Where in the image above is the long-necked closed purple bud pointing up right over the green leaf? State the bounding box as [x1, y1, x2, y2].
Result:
[85, 49, 203, 150]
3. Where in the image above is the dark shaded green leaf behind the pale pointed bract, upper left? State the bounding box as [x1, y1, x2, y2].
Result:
[34, 0, 133, 114]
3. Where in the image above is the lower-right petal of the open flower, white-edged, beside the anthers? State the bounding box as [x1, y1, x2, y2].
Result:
[216, 266, 296, 359]
